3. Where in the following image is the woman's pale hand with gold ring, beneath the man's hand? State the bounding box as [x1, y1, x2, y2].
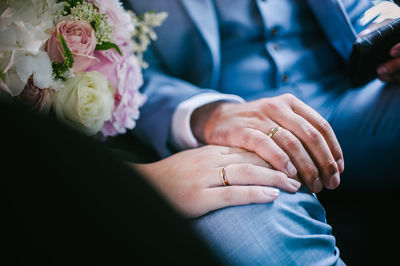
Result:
[133, 146, 300, 217]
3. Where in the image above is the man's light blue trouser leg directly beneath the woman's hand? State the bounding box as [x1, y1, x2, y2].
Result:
[193, 188, 343, 265]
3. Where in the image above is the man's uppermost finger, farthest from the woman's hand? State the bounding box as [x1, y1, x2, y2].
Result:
[291, 94, 344, 173]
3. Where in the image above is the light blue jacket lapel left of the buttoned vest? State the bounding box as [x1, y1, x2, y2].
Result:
[181, 0, 220, 88]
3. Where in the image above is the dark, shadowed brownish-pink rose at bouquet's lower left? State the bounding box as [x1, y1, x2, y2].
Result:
[14, 77, 53, 114]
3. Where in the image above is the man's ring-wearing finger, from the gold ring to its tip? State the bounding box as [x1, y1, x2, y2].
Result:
[272, 128, 323, 192]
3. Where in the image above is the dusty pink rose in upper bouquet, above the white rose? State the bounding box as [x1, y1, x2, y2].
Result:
[46, 20, 98, 72]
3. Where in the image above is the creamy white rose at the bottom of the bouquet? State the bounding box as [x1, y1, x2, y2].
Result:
[53, 71, 114, 135]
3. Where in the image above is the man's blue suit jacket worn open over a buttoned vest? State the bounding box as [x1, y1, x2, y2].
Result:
[128, 0, 371, 156]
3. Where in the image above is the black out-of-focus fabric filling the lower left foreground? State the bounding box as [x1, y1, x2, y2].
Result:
[0, 97, 218, 265]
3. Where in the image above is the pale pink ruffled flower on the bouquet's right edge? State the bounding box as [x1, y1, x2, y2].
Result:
[89, 49, 146, 136]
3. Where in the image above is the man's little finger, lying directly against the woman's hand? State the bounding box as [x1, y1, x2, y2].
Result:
[232, 128, 297, 177]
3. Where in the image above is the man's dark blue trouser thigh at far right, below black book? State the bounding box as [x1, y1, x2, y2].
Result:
[321, 81, 400, 189]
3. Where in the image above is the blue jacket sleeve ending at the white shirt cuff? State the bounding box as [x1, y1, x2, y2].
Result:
[133, 49, 218, 157]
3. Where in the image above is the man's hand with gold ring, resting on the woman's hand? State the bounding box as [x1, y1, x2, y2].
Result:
[191, 94, 344, 192]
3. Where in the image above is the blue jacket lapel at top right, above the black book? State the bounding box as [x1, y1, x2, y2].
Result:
[308, 0, 357, 59]
